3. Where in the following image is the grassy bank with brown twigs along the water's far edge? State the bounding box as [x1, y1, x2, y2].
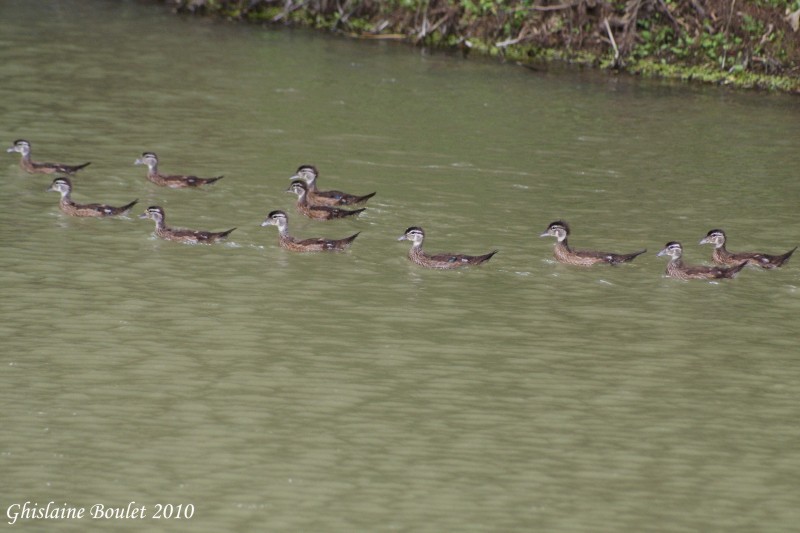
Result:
[164, 0, 800, 93]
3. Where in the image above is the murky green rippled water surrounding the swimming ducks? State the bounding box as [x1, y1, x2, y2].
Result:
[0, 0, 800, 532]
